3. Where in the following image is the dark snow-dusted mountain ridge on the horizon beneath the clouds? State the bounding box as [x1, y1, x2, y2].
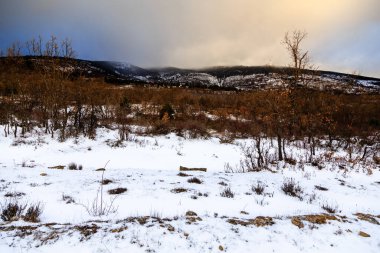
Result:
[2, 56, 380, 92]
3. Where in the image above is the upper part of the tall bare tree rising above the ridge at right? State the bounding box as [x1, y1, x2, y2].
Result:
[282, 30, 310, 84]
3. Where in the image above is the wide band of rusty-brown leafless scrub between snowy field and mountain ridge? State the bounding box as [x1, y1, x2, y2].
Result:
[0, 58, 380, 142]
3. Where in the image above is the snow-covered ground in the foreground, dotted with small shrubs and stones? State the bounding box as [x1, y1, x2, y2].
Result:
[0, 129, 380, 252]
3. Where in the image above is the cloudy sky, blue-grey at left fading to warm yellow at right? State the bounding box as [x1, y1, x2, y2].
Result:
[0, 0, 380, 77]
